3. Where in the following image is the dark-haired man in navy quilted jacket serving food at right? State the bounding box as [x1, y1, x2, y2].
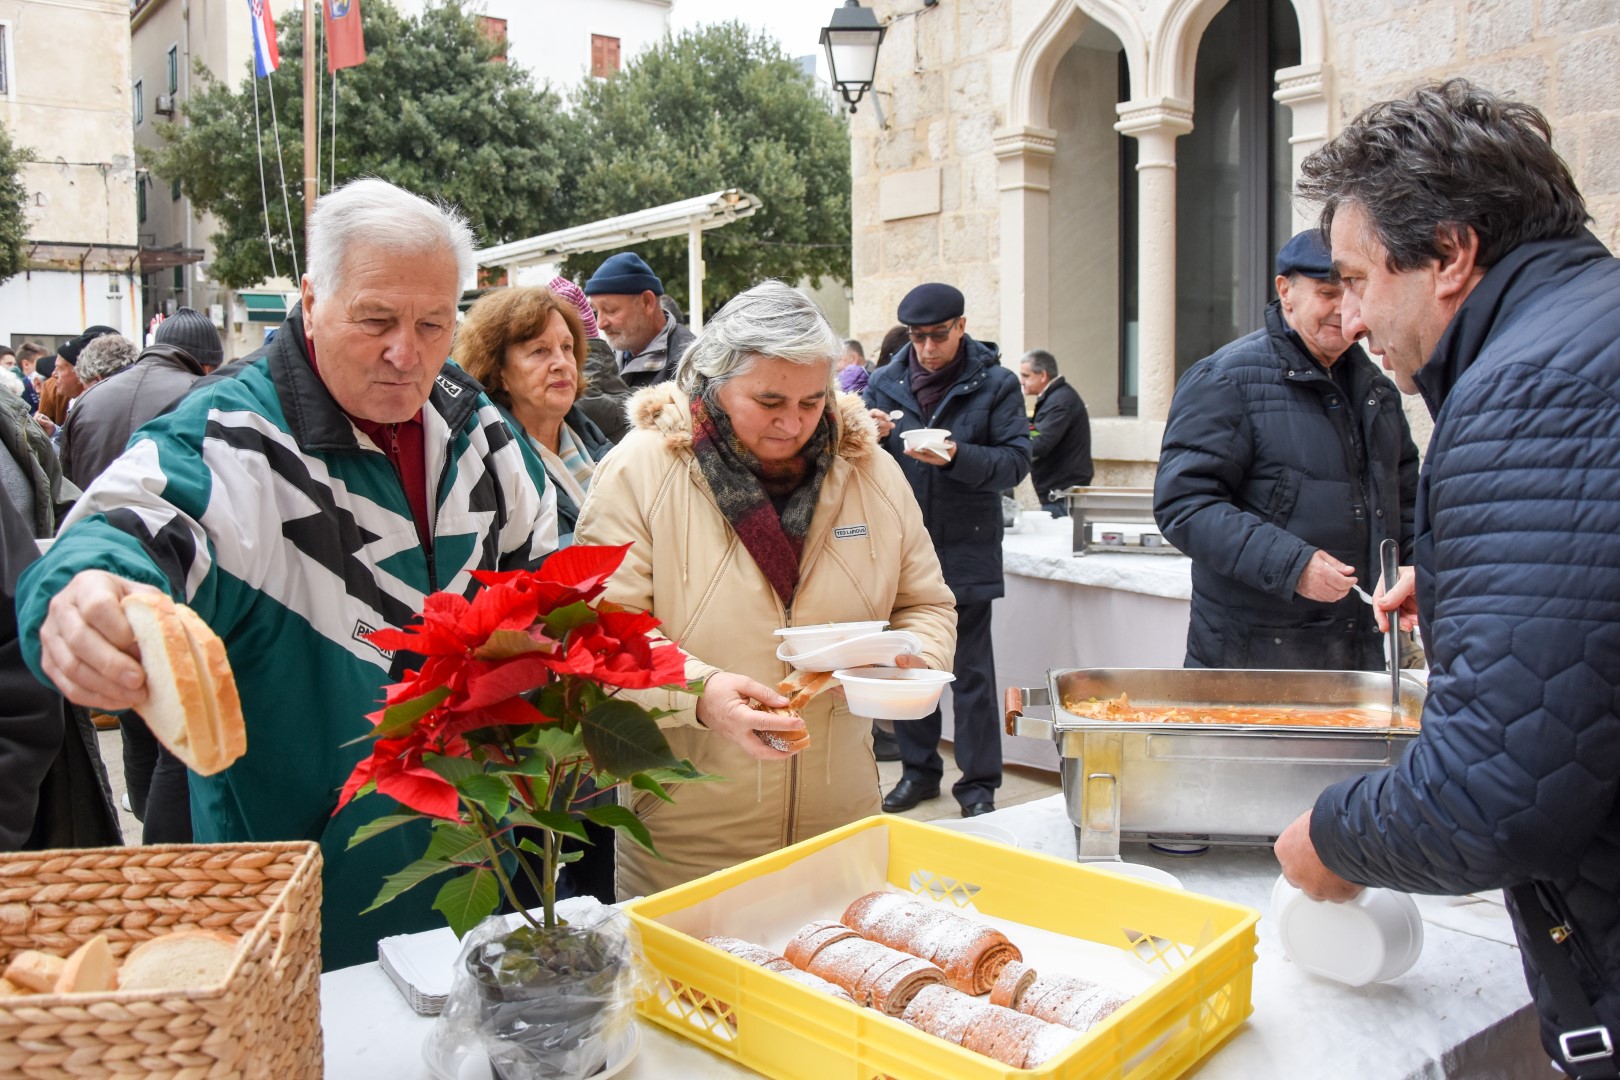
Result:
[1277, 81, 1620, 1077]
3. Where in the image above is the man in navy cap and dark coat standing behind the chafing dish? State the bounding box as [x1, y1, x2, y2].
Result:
[1153, 228, 1418, 670]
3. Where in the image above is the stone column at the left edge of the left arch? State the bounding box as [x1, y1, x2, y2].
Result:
[995, 128, 1058, 363]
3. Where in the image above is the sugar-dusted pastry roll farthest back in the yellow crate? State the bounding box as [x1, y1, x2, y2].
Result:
[842, 892, 1022, 994]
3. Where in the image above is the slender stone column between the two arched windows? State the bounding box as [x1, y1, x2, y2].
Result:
[1115, 97, 1192, 421]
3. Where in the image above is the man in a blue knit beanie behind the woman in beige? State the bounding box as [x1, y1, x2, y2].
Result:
[580, 251, 695, 439]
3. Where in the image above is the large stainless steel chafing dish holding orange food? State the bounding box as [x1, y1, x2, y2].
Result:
[1006, 667, 1426, 860]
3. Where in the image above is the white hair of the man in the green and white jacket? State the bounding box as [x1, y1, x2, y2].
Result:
[306, 176, 478, 300]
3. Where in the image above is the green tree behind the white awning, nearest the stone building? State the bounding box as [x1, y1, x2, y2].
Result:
[567, 23, 851, 318]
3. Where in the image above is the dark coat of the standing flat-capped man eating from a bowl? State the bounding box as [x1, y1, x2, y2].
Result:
[865, 335, 1029, 604]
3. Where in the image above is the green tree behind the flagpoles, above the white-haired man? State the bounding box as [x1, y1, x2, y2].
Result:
[143, 0, 577, 288]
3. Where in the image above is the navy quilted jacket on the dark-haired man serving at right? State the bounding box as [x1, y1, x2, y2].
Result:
[1311, 233, 1620, 1043]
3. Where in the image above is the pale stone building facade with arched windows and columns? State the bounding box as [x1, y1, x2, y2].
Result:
[851, 0, 1620, 484]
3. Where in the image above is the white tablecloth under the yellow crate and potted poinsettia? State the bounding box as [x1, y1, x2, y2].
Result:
[321, 795, 1558, 1080]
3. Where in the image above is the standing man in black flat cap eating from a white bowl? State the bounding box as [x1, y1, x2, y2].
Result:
[865, 283, 1030, 818]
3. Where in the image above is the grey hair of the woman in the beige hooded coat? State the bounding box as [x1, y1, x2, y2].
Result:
[676, 279, 844, 408]
